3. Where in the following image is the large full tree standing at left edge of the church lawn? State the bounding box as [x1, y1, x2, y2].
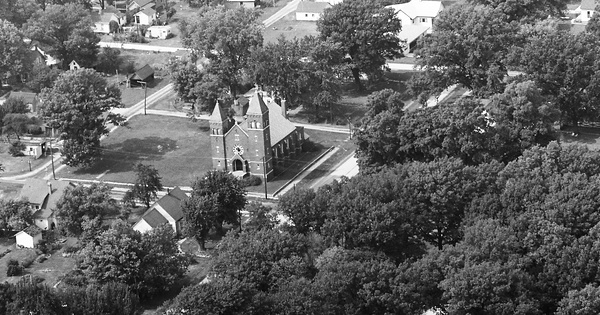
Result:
[40, 69, 124, 166]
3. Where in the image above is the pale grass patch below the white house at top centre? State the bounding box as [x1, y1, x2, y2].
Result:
[263, 13, 319, 43]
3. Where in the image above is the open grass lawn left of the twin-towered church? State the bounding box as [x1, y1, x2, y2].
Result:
[57, 115, 212, 186]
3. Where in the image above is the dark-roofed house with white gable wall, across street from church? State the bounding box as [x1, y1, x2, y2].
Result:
[133, 187, 188, 235]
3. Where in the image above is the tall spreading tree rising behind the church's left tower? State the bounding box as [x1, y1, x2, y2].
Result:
[180, 7, 263, 98]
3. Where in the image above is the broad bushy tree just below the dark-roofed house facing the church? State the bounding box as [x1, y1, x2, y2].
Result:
[78, 224, 189, 300]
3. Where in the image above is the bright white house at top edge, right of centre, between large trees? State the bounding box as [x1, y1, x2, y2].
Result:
[386, 0, 444, 53]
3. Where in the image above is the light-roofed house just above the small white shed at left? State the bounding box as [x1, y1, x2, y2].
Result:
[20, 178, 75, 230]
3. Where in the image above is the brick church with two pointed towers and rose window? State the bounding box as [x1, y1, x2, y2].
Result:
[210, 92, 304, 179]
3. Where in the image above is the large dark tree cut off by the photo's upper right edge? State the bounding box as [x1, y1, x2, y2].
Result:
[518, 30, 600, 125]
